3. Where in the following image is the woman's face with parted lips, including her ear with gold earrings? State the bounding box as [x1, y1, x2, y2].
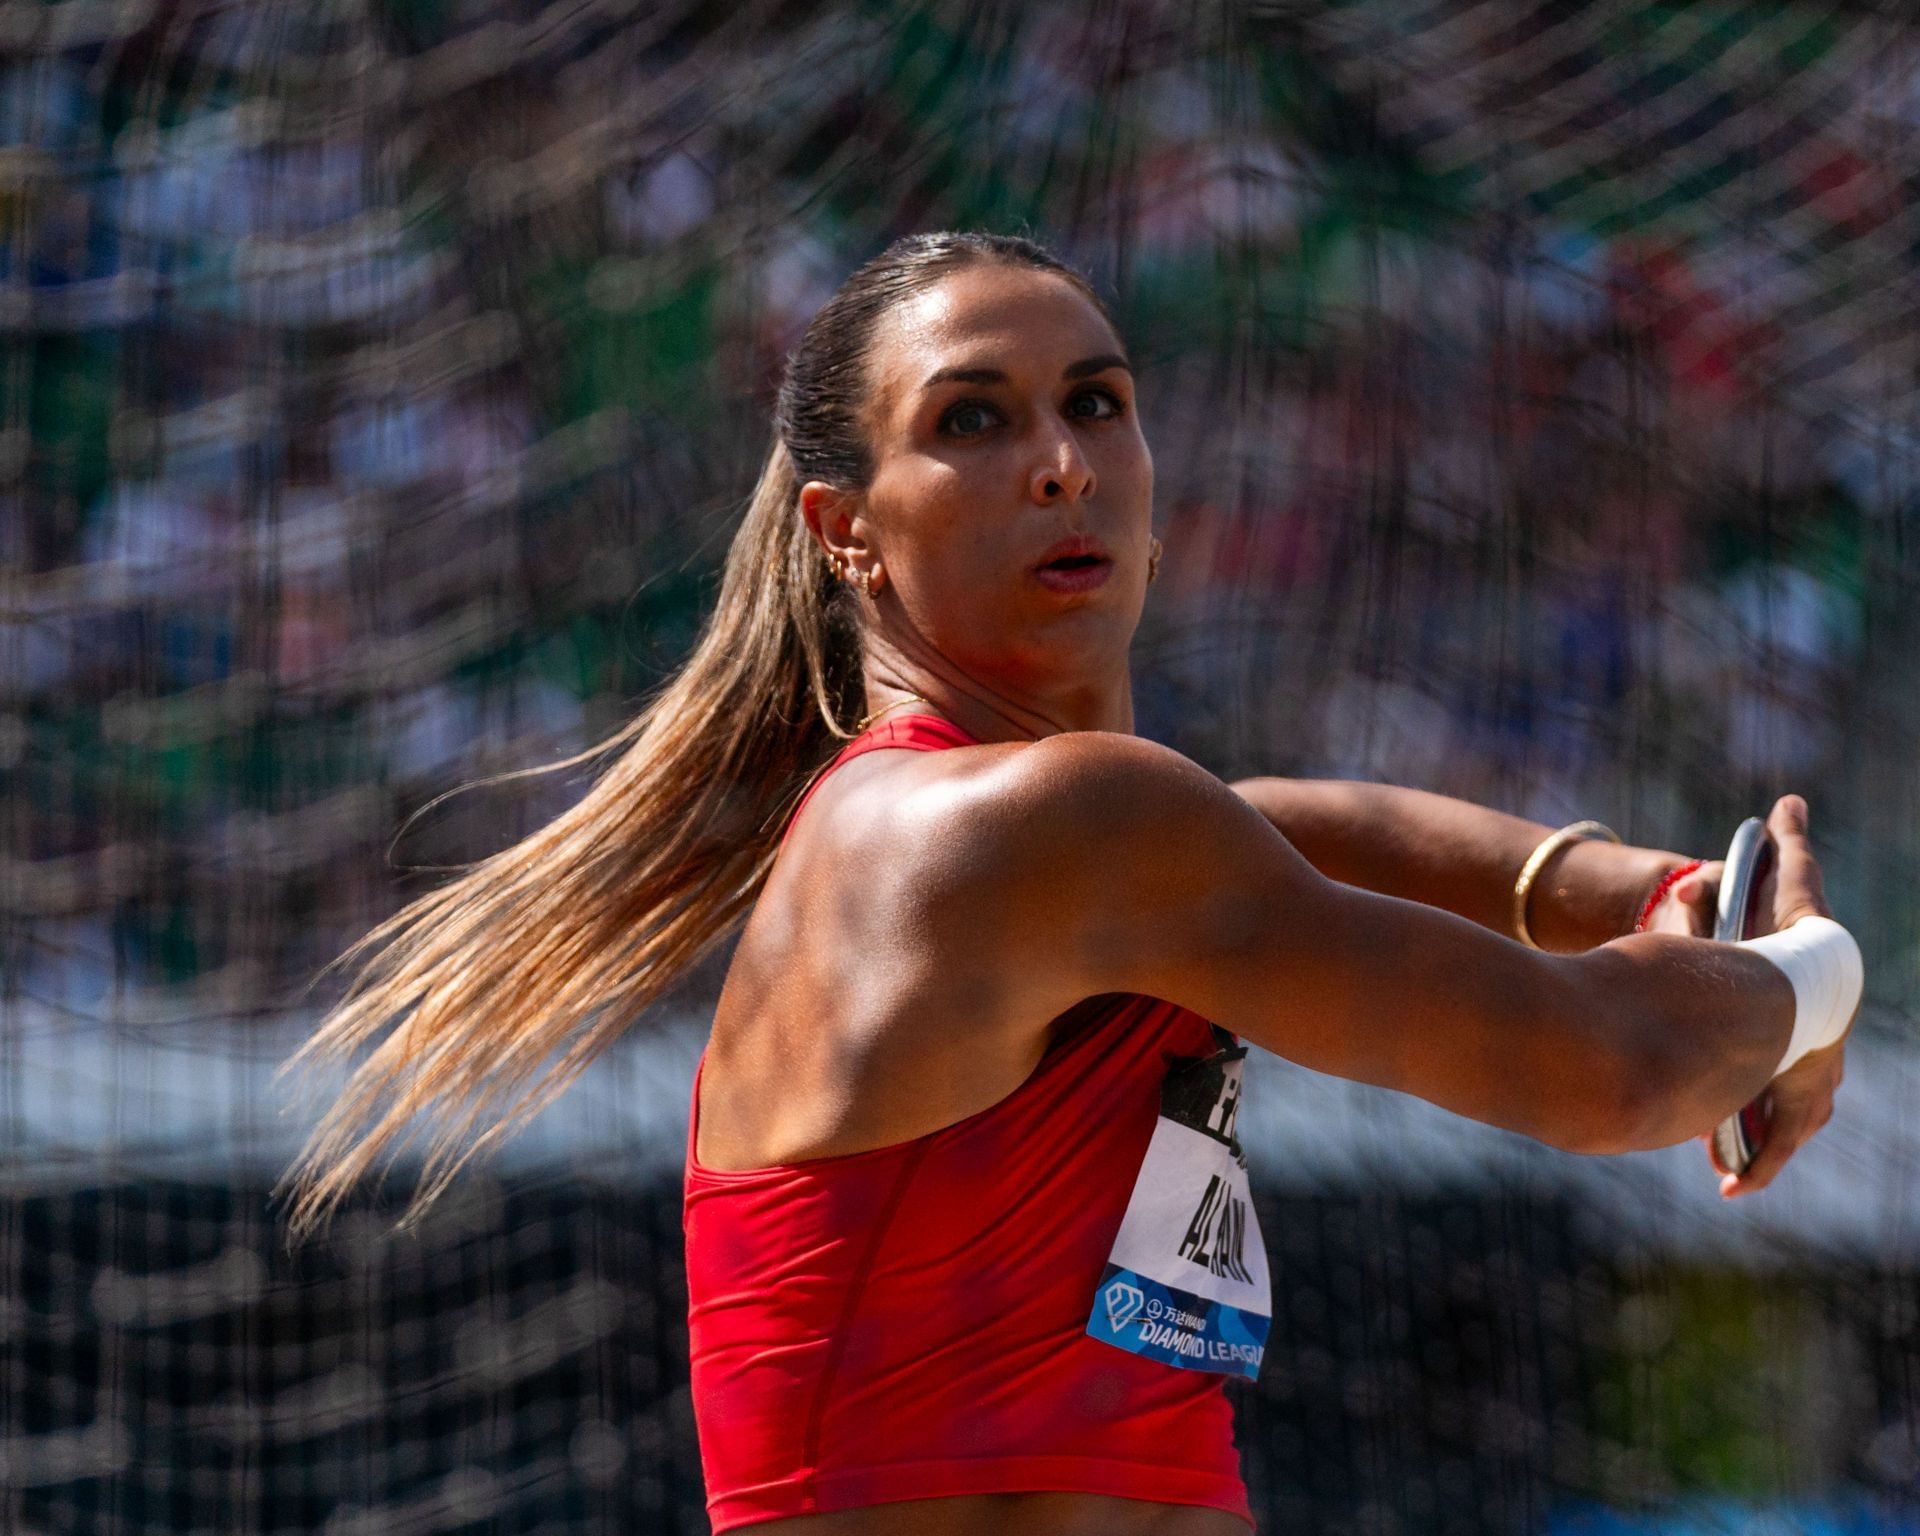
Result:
[803, 263, 1154, 701]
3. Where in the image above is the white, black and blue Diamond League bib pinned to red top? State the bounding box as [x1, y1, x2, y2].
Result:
[1087, 1025, 1273, 1377]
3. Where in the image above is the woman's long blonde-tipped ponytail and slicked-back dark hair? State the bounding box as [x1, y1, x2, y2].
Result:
[280, 234, 1098, 1240]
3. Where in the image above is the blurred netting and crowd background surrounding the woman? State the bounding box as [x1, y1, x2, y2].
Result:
[0, 0, 1920, 1536]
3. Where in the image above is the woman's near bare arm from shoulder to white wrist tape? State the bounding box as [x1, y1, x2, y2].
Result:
[906, 732, 1793, 1150]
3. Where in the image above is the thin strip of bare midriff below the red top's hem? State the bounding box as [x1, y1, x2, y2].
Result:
[747, 1494, 1250, 1536]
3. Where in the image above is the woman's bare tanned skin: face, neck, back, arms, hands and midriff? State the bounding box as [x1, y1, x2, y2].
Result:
[697, 265, 1843, 1536]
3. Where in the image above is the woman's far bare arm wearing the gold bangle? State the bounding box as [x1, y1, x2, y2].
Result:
[1231, 778, 1718, 952]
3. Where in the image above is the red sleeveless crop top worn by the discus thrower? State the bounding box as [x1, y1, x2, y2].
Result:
[685, 716, 1267, 1532]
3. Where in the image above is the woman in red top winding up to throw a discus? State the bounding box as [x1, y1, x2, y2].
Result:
[278, 234, 1859, 1536]
